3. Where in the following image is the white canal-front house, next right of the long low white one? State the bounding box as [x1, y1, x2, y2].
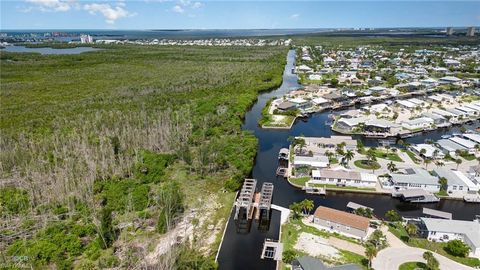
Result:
[384, 168, 440, 192]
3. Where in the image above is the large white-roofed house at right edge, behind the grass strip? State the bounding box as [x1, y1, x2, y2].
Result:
[420, 218, 480, 258]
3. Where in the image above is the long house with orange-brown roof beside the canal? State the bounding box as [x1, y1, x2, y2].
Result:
[313, 206, 373, 240]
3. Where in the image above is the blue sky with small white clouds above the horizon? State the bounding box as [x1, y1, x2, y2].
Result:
[0, 0, 480, 30]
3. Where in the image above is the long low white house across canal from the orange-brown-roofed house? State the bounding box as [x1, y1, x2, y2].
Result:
[309, 168, 377, 188]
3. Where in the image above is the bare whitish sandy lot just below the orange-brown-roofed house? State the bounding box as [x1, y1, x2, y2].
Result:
[294, 232, 341, 258]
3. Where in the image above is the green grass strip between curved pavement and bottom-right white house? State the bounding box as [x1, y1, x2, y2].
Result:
[388, 224, 480, 267]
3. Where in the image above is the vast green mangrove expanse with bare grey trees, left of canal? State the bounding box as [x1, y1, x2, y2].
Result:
[0, 45, 287, 269]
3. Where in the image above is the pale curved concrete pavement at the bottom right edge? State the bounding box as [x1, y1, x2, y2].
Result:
[372, 247, 473, 270]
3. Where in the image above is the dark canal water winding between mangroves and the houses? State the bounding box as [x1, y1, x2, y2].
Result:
[218, 50, 480, 270]
